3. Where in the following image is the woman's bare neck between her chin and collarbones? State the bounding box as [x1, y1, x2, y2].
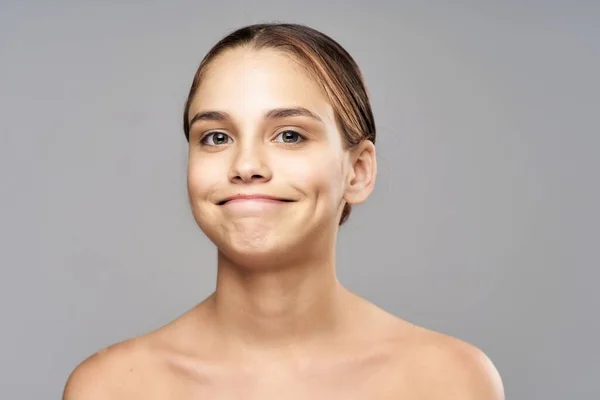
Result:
[210, 250, 352, 351]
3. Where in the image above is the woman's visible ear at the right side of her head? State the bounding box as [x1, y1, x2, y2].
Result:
[344, 140, 377, 204]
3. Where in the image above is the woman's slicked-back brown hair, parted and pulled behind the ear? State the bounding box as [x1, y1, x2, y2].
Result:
[183, 23, 375, 225]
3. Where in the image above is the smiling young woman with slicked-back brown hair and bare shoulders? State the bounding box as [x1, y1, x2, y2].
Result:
[64, 24, 504, 400]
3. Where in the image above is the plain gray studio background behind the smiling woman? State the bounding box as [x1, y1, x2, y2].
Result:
[0, 0, 600, 399]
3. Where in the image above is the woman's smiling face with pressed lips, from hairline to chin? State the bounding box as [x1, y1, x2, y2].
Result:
[188, 48, 351, 262]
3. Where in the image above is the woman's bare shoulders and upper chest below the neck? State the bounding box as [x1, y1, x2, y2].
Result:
[64, 289, 504, 400]
